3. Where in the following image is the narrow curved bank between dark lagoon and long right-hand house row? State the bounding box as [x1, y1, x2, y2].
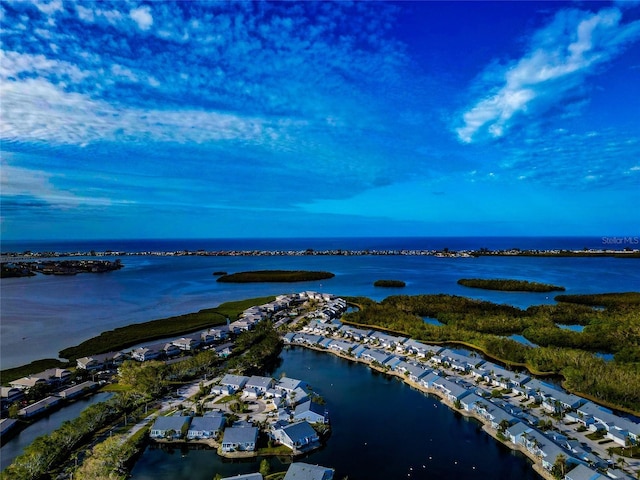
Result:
[289, 344, 555, 480]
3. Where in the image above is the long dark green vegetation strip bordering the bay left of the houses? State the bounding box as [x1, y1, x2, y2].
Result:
[57, 296, 275, 360]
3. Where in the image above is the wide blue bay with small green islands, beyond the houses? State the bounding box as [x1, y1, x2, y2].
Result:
[0, 253, 640, 368]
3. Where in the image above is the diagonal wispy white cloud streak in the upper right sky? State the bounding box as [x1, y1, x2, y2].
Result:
[456, 8, 640, 143]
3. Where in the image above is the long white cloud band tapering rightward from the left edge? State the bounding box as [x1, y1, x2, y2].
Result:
[0, 78, 291, 145]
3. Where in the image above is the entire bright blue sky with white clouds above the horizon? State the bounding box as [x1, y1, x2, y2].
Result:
[0, 0, 640, 240]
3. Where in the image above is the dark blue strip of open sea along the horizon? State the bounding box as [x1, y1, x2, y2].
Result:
[2, 237, 620, 253]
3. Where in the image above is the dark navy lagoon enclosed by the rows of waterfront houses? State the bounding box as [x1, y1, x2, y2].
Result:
[132, 347, 539, 480]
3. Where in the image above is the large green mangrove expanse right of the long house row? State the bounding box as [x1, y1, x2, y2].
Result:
[343, 294, 640, 412]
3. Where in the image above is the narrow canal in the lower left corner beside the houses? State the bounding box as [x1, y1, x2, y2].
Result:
[0, 393, 112, 470]
